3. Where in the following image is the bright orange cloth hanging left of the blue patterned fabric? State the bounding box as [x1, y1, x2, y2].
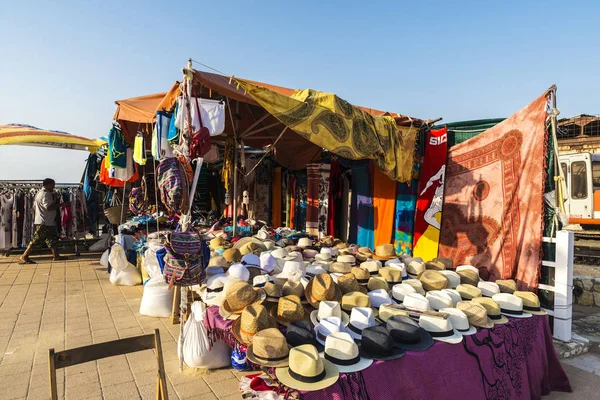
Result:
[373, 166, 396, 246]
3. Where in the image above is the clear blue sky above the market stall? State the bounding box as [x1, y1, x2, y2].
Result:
[0, 0, 600, 181]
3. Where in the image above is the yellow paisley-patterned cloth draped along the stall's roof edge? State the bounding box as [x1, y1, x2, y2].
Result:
[237, 79, 418, 182]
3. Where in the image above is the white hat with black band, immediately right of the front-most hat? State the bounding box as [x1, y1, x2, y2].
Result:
[324, 332, 373, 374]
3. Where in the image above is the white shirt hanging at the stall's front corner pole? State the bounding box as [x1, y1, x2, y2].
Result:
[175, 96, 225, 136]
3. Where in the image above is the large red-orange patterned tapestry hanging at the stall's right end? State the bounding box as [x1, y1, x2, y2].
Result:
[439, 95, 548, 289]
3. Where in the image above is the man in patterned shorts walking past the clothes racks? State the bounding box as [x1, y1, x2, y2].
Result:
[21, 178, 66, 264]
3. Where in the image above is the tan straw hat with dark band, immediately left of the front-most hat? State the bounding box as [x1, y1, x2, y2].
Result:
[246, 328, 290, 368]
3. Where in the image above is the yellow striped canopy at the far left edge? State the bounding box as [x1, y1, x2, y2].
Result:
[0, 124, 105, 153]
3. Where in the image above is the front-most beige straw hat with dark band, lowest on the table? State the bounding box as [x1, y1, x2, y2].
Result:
[275, 344, 339, 390]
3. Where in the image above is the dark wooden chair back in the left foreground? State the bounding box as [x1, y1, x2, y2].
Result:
[48, 329, 169, 400]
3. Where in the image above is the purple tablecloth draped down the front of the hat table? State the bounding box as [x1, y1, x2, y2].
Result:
[205, 307, 571, 400]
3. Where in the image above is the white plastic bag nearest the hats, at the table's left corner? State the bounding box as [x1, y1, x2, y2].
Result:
[179, 301, 231, 369]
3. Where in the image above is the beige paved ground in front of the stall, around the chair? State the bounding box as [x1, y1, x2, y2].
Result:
[0, 256, 600, 400]
